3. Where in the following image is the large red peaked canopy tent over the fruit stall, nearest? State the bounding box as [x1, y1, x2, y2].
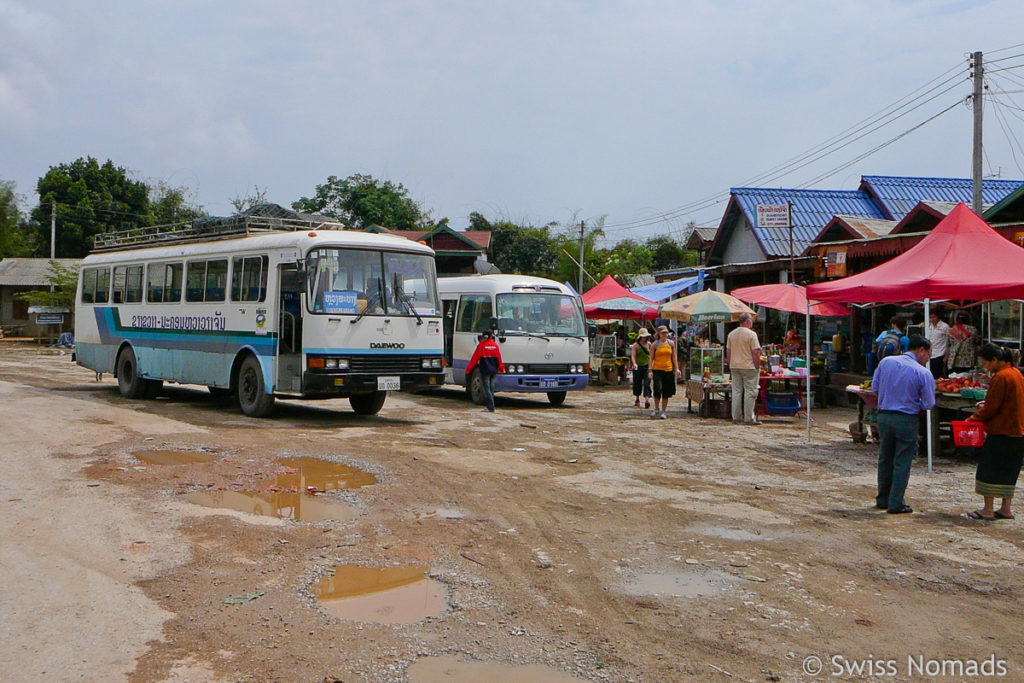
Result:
[807, 203, 1024, 303]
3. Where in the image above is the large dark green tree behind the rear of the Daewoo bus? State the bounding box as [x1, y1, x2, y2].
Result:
[32, 157, 150, 258]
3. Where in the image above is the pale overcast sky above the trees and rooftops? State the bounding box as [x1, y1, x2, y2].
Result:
[0, 0, 1024, 240]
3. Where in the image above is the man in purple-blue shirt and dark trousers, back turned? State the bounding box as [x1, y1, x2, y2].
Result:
[871, 335, 935, 515]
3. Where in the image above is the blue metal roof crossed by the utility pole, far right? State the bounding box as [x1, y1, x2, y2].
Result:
[860, 175, 1024, 220]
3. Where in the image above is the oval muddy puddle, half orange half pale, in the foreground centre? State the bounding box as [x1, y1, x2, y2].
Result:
[311, 564, 446, 624]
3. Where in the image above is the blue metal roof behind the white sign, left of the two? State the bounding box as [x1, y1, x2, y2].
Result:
[730, 187, 888, 256]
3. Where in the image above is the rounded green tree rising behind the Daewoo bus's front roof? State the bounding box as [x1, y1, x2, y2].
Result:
[292, 173, 431, 230]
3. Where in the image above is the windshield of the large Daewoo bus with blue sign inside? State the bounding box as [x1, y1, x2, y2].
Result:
[306, 247, 439, 315]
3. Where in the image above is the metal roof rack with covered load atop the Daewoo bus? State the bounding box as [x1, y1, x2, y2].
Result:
[93, 204, 345, 252]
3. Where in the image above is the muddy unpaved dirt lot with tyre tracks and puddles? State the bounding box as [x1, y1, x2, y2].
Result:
[0, 344, 1024, 682]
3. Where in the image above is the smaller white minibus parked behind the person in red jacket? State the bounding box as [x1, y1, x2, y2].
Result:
[437, 274, 590, 405]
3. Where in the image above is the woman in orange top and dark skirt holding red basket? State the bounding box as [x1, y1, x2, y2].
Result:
[968, 344, 1024, 519]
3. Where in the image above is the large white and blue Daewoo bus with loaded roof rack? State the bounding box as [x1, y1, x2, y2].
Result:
[75, 215, 443, 417]
